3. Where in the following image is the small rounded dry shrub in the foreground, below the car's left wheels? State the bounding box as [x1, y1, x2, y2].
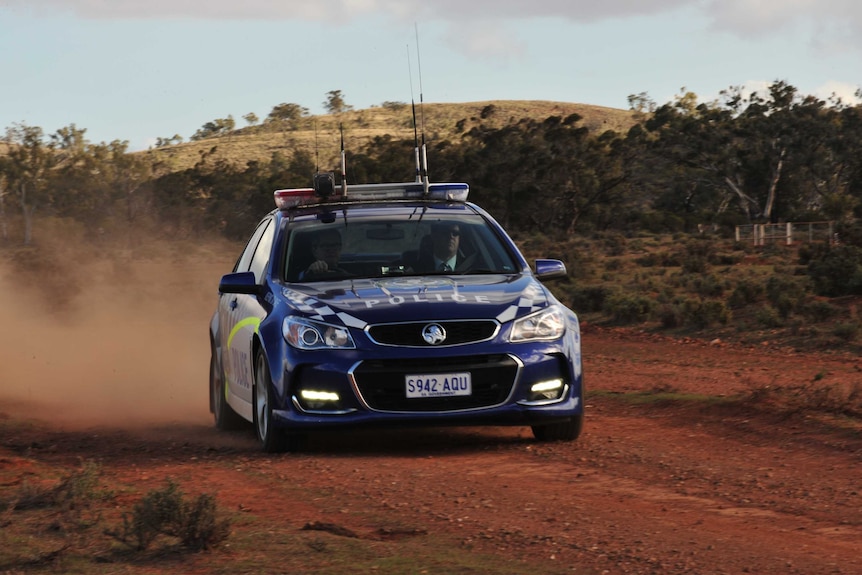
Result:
[115, 482, 235, 551]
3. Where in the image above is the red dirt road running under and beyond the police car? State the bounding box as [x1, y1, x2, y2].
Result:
[2, 330, 862, 574]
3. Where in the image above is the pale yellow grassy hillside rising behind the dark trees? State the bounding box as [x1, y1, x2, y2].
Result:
[145, 100, 633, 171]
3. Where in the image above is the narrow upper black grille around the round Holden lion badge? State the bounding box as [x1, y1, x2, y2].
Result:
[368, 320, 500, 347]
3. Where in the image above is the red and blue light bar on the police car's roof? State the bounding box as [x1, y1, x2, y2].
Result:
[274, 182, 470, 210]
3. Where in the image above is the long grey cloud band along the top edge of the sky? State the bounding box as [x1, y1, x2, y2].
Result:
[10, 0, 862, 55]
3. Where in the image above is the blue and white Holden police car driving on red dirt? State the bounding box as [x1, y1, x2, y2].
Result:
[209, 174, 584, 452]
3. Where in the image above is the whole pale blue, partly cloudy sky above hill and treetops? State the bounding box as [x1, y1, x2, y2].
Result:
[0, 0, 862, 150]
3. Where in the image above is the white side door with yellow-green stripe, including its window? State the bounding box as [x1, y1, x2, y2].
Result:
[219, 217, 274, 412]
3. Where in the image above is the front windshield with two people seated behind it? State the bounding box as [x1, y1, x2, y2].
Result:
[284, 212, 518, 282]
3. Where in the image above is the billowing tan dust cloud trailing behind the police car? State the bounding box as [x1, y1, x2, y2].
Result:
[0, 231, 239, 428]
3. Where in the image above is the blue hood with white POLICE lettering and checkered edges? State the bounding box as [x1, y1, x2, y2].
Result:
[282, 274, 549, 328]
